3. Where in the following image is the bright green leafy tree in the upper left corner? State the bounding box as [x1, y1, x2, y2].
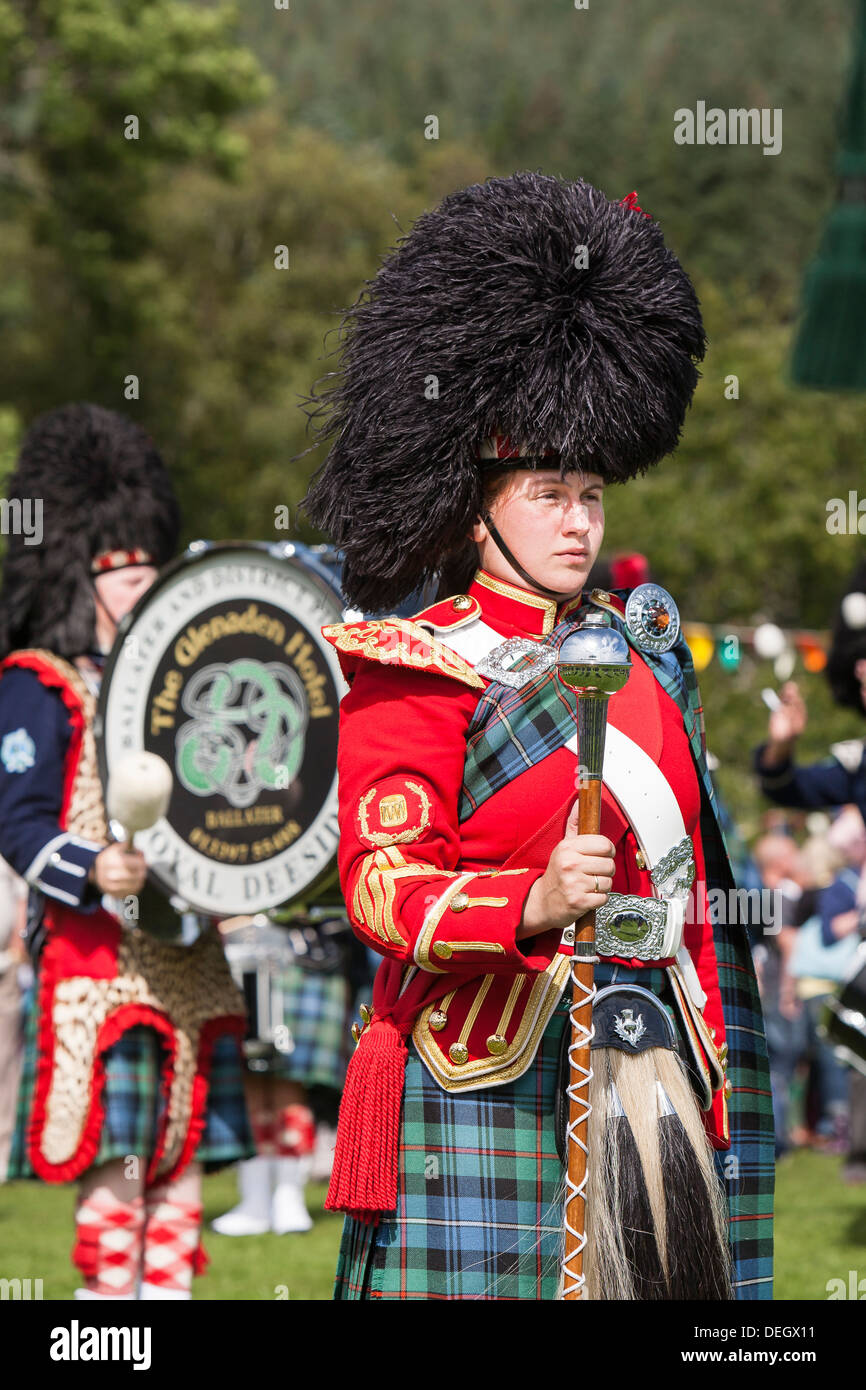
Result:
[0, 0, 268, 413]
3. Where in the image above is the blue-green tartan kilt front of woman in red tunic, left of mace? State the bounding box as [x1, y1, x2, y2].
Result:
[335, 1009, 567, 1300]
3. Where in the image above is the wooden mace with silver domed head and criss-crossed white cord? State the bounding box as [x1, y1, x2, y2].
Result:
[557, 612, 631, 1300]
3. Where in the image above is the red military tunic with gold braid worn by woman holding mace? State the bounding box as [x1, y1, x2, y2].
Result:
[324, 571, 727, 1212]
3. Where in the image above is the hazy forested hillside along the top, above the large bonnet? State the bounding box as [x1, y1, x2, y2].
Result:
[233, 0, 852, 310]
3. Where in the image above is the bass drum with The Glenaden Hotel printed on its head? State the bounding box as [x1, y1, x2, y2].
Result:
[96, 541, 353, 919]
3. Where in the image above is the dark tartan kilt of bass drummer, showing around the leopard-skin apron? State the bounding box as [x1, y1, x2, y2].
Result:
[7, 1001, 256, 1180]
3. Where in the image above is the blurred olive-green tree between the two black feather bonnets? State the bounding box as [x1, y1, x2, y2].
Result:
[136, 113, 423, 539]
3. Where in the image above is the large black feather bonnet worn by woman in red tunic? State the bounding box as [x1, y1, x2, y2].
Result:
[304, 172, 706, 610]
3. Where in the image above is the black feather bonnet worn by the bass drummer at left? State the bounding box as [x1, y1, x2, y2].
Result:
[0, 404, 179, 657]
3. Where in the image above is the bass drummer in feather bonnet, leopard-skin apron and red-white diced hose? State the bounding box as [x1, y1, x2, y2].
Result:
[0, 403, 252, 1301]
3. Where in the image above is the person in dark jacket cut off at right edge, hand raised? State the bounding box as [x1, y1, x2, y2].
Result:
[755, 562, 866, 1182]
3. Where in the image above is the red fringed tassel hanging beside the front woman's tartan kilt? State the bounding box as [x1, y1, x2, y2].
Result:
[325, 1019, 407, 1220]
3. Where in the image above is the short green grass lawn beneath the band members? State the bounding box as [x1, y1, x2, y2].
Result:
[0, 1151, 866, 1301]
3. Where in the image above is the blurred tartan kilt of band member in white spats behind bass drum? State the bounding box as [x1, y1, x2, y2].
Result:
[261, 965, 352, 1091]
